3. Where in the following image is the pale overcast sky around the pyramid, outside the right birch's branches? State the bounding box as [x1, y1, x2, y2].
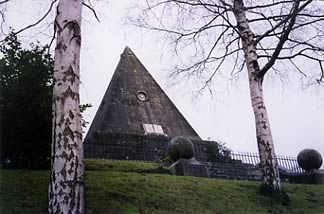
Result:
[7, 0, 324, 156]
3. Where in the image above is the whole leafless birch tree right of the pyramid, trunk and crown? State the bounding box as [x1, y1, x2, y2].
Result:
[131, 0, 324, 193]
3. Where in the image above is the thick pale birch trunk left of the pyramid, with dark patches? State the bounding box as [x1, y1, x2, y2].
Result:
[48, 0, 84, 214]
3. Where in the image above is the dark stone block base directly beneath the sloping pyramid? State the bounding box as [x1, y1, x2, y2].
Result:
[84, 133, 220, 162]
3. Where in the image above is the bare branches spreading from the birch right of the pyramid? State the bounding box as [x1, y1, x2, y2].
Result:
[131, 0, 324, 85]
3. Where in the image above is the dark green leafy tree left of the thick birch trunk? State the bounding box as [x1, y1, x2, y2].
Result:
[0, 35, 54, 168]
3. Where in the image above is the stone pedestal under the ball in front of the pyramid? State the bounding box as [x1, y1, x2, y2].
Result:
[169, 159, 209, 177]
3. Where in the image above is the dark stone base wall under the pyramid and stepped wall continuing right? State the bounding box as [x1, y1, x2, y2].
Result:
[84, 133, 261, 180]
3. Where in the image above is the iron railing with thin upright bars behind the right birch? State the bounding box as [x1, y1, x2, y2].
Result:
[231, 152, 303, 172]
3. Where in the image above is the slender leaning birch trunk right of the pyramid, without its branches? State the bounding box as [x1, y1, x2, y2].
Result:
[234, 0, 281, 192]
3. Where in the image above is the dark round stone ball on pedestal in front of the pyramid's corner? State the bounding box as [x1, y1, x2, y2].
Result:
[168, 136, 194, 162]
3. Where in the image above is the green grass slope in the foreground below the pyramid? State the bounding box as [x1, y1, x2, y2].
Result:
[0, 160, 324, 214]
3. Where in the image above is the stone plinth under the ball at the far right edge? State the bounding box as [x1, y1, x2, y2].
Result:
[290, 169, 324, 184]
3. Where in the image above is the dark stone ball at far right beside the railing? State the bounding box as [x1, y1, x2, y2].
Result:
[297, 149, 323, 171]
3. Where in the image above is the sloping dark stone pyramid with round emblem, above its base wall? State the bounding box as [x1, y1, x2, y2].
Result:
[85, 47, 200, 141]
